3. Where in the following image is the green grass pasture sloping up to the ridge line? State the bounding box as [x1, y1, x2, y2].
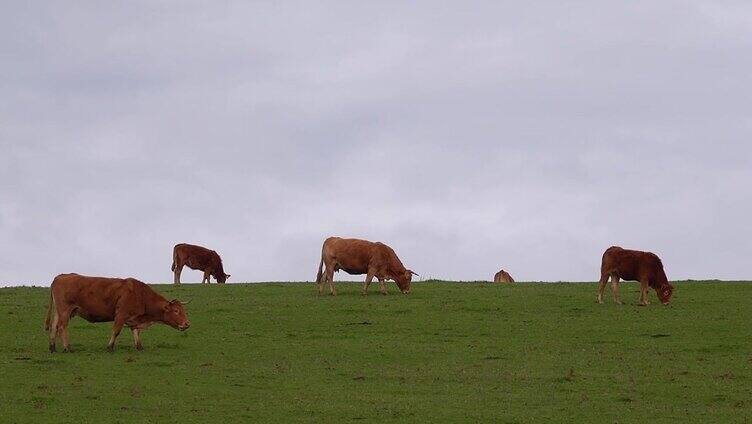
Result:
[0, 282, 752, 423]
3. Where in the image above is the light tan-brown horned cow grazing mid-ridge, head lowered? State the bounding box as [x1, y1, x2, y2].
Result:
[316, 237, 418, 296]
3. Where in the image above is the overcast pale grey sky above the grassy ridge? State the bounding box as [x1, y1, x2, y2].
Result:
[0, 1, 752, 285]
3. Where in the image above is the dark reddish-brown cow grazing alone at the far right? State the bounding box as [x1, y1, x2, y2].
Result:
[596, 246, 674, 306]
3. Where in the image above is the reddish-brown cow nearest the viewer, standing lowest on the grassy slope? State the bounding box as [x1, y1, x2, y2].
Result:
[45, 274, 191, 352]
